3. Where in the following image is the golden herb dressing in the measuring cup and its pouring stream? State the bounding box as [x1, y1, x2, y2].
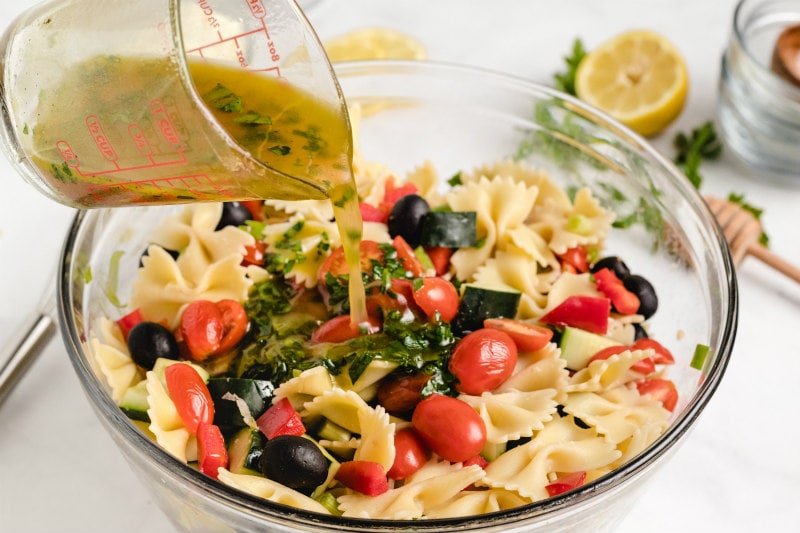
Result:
[28, 56, 367, 324]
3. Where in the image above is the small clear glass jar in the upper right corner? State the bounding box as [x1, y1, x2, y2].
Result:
[718, 0, 800, 185]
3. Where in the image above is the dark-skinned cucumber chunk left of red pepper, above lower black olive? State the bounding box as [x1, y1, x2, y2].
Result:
[208, 378, 275, 429]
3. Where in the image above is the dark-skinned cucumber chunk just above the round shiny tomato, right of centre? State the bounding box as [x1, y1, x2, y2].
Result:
[452, 284, 521, 333]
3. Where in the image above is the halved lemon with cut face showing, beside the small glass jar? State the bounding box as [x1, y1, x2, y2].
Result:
[575, 30, 689, 136]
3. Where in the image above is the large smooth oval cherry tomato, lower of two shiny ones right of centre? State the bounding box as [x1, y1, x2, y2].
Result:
[411, 394, 486, 463]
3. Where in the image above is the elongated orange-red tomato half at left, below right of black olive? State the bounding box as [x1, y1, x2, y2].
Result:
[164, 363, 214, 434]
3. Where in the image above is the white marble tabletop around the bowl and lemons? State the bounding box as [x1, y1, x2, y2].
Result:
[0, 0, 800, 533]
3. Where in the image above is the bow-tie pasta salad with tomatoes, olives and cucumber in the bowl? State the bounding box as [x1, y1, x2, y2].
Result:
[91, 131, 678, 519]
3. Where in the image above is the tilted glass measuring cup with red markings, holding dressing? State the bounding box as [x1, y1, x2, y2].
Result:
[0, 0, 351, 208]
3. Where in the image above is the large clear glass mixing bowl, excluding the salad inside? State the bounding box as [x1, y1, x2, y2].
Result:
[59, 62, 737, 532]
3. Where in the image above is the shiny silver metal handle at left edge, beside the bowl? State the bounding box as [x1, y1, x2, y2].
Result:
[0, 313, 56, 405]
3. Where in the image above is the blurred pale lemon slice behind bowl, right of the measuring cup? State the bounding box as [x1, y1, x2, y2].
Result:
[324, 28, 427, 63]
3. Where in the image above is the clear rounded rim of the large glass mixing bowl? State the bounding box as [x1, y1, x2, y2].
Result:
[57, 60, 738, 531]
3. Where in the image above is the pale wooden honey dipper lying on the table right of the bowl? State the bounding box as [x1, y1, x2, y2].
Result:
[705, 196, 800, 283]
